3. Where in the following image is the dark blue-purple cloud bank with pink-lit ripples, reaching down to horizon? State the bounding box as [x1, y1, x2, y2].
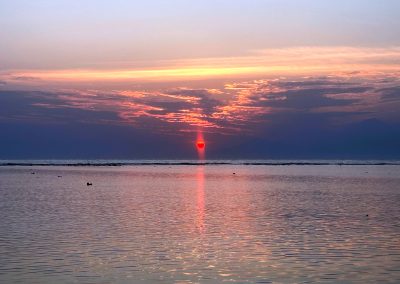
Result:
[0, 73, 400, 158]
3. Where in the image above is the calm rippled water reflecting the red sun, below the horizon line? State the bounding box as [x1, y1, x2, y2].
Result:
[0, 165, 400, 283]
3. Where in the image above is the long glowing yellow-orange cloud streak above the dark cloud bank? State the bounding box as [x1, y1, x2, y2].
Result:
[0, 47, 400, 85]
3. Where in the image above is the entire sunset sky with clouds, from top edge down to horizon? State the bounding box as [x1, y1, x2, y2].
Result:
[0, 0, 400, 159]
